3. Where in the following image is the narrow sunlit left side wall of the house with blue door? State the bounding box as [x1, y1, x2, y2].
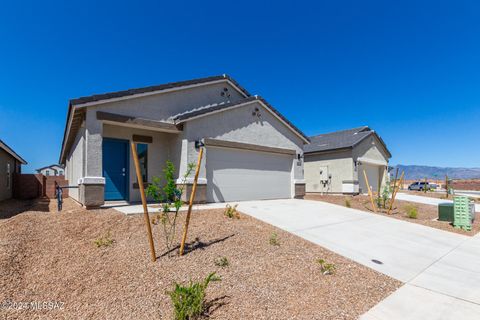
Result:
[65, 124, 85, 201]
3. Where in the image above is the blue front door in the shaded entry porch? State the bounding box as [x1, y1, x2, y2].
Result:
[103, 138, 129, 200]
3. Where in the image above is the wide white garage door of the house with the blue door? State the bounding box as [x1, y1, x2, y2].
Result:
[206, 147, 293, 202]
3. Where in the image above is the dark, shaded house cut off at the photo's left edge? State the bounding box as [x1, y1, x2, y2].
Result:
[0, 140, 27, 201]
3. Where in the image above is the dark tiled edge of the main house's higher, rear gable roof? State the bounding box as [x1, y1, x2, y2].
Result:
[70, 74, 250, 105]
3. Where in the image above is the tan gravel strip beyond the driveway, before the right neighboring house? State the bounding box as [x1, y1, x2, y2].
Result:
[305, 194, 480, 236]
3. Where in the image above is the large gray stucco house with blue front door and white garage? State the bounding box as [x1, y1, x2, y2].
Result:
[60, 75, 309, 207]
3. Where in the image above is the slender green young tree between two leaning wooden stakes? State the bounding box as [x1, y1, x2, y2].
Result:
[146, 160, 195, 250]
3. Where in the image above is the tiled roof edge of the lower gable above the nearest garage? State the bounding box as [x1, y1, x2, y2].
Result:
[171, 96, 310, 143]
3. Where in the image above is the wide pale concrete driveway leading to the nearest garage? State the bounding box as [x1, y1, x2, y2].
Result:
[234, 199, 480, 319]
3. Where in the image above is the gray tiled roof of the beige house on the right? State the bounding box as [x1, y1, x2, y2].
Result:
[304, 126, 392, 158]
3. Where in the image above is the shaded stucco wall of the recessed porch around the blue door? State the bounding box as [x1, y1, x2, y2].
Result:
[103, 124, 178, 201]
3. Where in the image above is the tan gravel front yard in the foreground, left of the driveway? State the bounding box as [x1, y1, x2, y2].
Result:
[0, 199, 401, 319]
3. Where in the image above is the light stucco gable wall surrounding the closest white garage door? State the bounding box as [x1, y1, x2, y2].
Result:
[183, 102, 303, 185]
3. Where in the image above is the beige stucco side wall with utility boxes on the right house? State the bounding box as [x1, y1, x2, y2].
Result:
[305, 150, 354, 193]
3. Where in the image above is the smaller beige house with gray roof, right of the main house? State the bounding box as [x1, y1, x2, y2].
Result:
[304, 126, 392, 194]
